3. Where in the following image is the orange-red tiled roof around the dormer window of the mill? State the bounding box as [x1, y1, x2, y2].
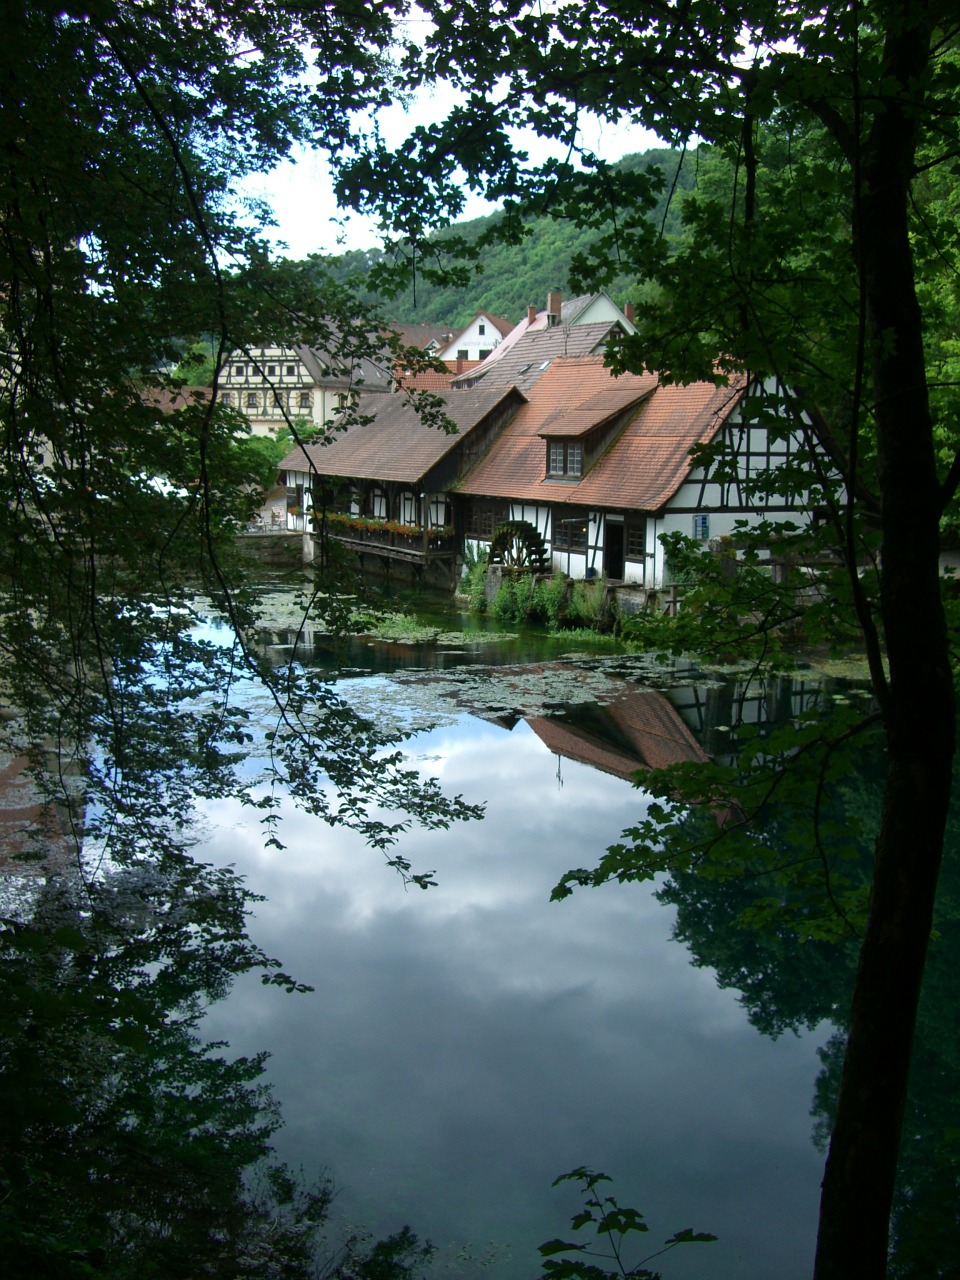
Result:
[461, 356, 744, 512]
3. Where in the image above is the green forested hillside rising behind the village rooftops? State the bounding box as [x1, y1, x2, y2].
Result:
[316, 148, 698, 329]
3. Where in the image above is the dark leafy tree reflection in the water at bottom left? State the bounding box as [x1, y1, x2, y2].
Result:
[0, 860, 430, 1280]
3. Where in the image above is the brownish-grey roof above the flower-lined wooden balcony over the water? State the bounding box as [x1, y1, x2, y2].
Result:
[279, 387, 524, 484]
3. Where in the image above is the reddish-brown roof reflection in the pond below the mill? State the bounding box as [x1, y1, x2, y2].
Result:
[527, 689, 707, 780]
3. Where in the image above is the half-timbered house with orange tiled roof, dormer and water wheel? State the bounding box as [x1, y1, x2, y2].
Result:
[460, 355, 805, 589]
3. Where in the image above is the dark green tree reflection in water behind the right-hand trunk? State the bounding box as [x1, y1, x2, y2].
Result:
[657, 727, 960, 1280]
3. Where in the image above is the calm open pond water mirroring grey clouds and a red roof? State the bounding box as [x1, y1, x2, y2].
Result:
[205, 583, 829, 1280]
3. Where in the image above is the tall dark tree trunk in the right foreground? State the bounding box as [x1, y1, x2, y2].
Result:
[814, 0, 955, 1280]
